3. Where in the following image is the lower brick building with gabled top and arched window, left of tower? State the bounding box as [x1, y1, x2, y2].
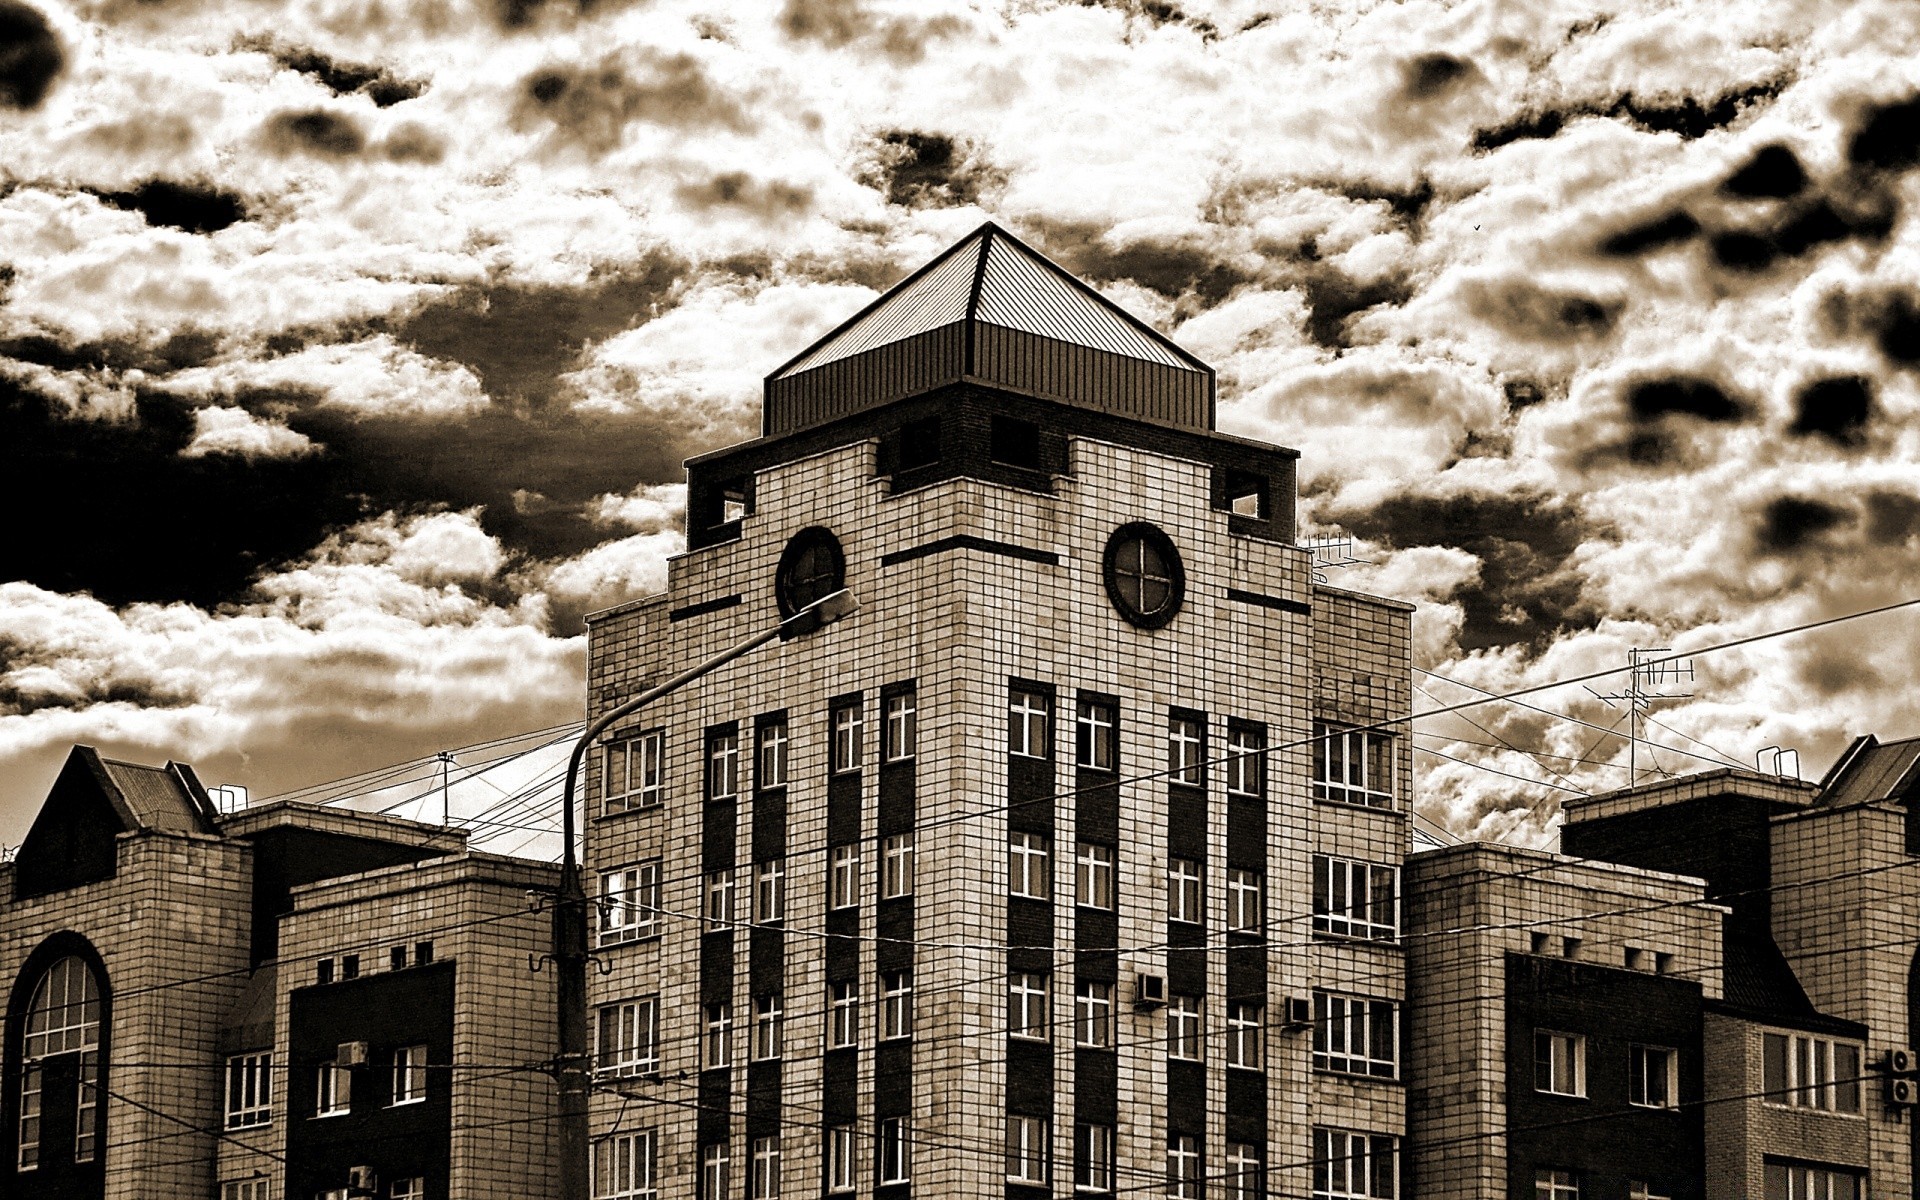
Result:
[0, 747, 555, 1200]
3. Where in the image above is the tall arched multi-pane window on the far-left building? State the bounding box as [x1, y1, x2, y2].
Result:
[19, 954, 100, 1171]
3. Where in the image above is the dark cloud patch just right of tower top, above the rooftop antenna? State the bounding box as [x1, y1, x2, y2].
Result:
[1338, 493, 1603, 651]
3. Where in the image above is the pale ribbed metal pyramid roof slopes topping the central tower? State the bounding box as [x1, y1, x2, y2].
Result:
[770, 221, 1208, 378]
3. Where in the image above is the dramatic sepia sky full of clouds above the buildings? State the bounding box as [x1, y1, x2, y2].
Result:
[0, 0, 1920, 845]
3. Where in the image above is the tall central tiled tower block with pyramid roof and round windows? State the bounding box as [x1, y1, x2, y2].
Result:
[586, 225, 1411, 1200]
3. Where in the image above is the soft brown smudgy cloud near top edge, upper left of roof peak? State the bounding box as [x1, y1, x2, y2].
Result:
[518, 52, 749, 154]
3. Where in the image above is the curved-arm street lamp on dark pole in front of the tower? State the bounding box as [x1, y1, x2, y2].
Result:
[553, 588, 860, 1200]
